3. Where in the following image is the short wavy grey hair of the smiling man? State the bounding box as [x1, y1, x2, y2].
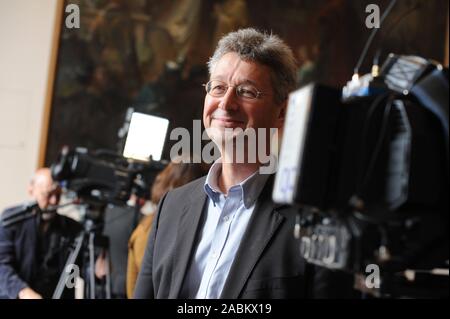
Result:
[208, 28, 297, 103]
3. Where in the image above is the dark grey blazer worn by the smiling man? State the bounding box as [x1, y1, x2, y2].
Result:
[134, 177, 356, 299]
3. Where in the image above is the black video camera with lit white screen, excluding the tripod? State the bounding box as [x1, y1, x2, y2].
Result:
[51, 112, 169, 210]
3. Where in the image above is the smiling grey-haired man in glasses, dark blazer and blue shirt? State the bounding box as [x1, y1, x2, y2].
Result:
[134, 29, 352, 299]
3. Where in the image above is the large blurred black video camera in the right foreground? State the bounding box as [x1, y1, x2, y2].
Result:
[273, 55, 449, 298]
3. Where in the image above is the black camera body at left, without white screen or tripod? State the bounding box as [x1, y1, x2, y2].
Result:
[51, 147, 165, 205]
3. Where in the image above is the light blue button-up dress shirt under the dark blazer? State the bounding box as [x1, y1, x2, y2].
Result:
[182, 162, 269, 299]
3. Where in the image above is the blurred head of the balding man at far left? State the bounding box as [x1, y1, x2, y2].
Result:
[31, 174, 61, 211]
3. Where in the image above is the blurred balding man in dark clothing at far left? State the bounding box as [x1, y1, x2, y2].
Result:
[0, 168, 81, 299]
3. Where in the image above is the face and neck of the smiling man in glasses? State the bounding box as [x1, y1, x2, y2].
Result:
[203, 48, 284, 175]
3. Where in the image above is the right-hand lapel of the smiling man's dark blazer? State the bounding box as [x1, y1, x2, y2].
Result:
[220, 178, 284, 299]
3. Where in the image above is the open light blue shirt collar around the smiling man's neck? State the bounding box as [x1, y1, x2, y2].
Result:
[204, 159, 270, 209]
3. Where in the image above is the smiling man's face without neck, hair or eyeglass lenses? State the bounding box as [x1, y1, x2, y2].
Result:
[203, 53, 285, 145]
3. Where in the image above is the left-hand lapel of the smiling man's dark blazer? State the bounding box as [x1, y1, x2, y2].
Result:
[169, 179, 206, 299]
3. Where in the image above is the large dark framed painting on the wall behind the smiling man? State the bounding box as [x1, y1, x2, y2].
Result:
[43, 0, 448, 165]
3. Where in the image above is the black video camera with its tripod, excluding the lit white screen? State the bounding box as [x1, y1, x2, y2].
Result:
[51, 147, 164, 299]
